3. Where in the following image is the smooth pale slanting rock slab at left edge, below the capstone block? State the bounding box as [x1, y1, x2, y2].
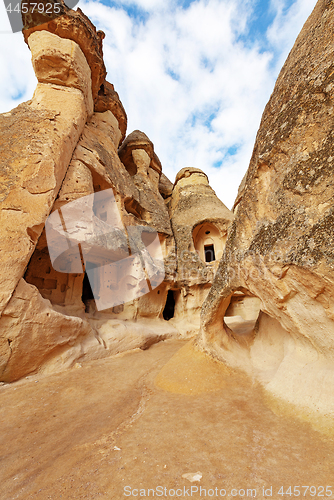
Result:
[0, 84, 87, 313]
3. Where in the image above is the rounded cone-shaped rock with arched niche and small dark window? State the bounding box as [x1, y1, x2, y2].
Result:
[169, 168, 233, 334]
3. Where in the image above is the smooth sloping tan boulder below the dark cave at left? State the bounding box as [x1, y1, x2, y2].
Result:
[0, 279, 94, 382]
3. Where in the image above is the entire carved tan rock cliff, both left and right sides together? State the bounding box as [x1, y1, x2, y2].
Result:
[0, 0, 334, 422]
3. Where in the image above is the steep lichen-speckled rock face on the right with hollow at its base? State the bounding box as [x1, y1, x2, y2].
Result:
[198, 0, 334, 413]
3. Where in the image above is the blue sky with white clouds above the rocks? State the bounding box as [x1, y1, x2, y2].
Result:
[0, 0, 316, 208]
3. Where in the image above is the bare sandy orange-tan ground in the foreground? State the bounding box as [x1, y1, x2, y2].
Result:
[0, 341, 334, 500]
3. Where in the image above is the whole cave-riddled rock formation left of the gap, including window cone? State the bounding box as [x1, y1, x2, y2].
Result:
[0, 6, 233, 382]
